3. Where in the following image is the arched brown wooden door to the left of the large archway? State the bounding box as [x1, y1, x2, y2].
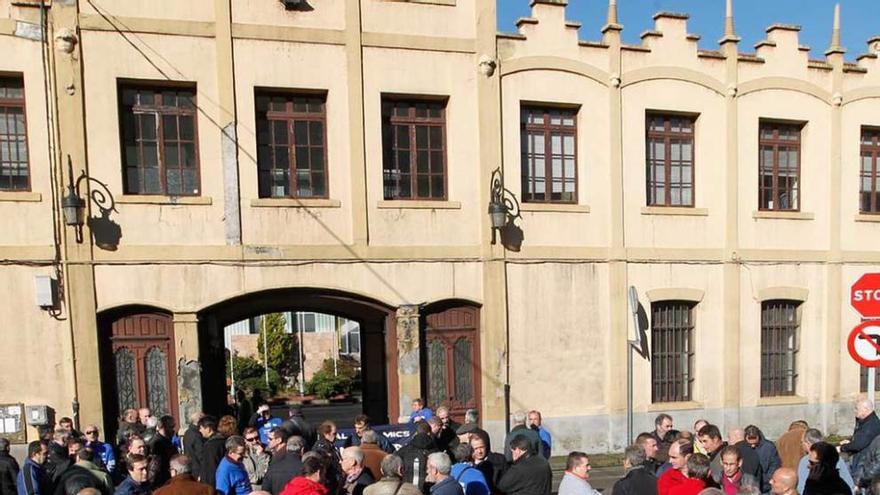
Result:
[110, 313, 180, 424]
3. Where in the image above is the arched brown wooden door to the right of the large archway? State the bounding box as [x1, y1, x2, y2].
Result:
[425, 306, 480, 422]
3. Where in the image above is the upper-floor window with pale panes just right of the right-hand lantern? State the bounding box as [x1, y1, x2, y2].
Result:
[520, 106, 577, 203]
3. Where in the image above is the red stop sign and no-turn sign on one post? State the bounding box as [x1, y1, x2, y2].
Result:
[847, 273, 880, 405]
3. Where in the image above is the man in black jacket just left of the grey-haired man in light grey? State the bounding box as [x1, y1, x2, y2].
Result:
[498, 436, 552, 495]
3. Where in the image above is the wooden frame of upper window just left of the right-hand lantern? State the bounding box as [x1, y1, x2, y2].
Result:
[381, 95, 449, 201]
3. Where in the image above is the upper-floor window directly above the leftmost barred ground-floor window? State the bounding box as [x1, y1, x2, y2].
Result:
[645, 113, 696, 206]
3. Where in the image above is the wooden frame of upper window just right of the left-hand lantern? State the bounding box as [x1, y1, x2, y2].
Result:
[117, 80, 202, 197]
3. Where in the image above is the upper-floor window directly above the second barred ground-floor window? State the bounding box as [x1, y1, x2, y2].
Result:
[758, 121, 801, 211]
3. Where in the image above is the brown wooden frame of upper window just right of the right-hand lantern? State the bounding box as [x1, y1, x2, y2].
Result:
[520, 103, 580, 204]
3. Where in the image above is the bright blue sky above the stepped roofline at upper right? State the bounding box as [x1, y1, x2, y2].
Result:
[498, 0, 880, 59]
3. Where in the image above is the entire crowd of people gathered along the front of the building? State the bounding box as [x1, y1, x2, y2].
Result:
[0, 399, 880, 495]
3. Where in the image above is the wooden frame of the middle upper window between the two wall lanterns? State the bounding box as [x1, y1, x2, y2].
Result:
[254, 88, 330, 199]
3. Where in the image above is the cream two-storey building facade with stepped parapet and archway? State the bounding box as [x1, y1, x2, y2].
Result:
[0, 0, 880, 453]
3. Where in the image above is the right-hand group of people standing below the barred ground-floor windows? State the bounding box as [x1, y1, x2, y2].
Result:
[604, 398, 880, 495]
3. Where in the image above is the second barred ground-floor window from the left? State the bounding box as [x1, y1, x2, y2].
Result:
[761, 300, 800, 397]
